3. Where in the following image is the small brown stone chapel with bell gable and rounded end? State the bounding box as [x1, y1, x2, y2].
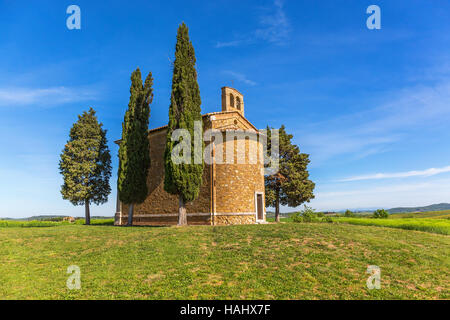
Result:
[115, 87, 266, 225]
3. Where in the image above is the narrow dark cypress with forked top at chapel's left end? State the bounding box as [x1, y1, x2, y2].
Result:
[117, 68, 153, 226]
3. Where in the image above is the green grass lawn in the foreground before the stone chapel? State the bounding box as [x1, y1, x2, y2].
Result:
[0, 223, 450, 299]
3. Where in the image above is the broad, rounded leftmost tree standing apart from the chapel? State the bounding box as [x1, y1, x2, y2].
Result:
[59, 108, 111, 224]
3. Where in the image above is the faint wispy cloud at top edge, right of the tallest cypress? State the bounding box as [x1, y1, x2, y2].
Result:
[215, 0, 291, 48]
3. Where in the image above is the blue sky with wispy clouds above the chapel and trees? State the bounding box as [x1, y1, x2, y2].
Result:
[0, 0, 450, 217]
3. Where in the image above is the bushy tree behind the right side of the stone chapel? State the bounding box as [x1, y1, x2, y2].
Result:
[265, 125, 315, 222]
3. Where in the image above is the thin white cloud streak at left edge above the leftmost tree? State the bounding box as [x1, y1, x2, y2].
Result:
[0, 86, 97, 107]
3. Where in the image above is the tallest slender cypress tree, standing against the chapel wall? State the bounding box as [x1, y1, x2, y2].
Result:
[164, 22, 204, 225]
